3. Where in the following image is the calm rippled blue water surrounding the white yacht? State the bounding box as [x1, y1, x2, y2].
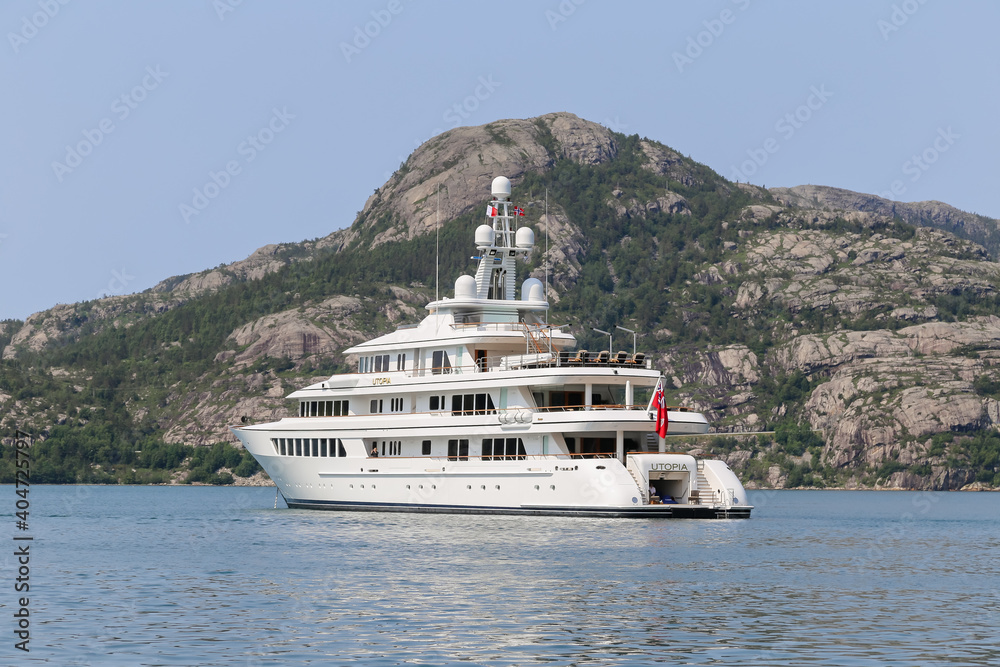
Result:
[0, 486, 1000, 666]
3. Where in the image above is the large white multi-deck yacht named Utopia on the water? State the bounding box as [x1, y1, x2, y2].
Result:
[232, 176, 753, 518]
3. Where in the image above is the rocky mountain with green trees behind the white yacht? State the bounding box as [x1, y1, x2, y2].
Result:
[0, 113, 1000, 489]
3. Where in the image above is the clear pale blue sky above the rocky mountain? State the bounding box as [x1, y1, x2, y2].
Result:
[0, 0, 1000, 319]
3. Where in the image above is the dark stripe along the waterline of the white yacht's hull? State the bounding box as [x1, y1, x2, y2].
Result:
[285, 498, 753, 519]
